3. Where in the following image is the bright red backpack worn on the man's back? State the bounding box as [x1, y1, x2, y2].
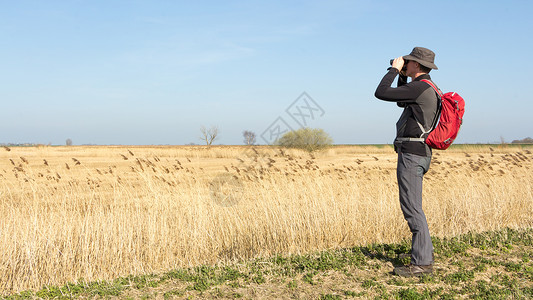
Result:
[421, 79, 465, 150]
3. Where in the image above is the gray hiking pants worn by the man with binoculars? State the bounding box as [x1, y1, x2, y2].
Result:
[396, 152, 433, 265]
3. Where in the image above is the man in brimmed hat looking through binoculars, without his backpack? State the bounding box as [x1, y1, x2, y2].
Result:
[375, 47, 440, 276]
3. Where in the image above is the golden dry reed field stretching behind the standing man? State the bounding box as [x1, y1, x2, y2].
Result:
[0, 146, 533, 294]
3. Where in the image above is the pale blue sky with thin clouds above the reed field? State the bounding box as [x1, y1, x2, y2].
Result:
[0, 0, 533, 145]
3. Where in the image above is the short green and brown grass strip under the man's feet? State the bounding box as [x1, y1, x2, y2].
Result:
[6, 229, 533, 299]
